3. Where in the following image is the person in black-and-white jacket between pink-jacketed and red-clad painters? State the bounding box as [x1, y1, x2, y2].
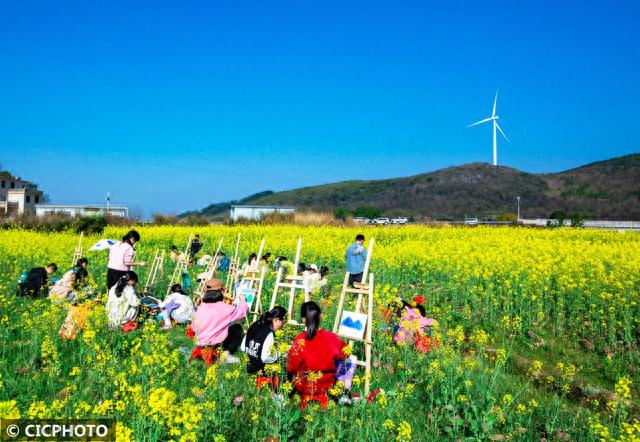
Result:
[240, 306, 287, 388]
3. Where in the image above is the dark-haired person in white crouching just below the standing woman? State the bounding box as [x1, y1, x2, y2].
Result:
[105, 270, 140, 331]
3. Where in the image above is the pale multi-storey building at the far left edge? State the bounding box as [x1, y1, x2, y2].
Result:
[0, 172, 44, 216]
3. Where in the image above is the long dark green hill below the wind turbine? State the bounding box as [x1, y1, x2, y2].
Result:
[188, 154, 640, 220]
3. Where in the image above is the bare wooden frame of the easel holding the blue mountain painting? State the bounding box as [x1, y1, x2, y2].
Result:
[333, 238, 374, 396]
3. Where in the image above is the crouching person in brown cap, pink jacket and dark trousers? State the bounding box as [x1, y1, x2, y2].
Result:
[191, 278, 249, 364]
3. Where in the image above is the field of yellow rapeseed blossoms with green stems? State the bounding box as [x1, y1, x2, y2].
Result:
[0, 226, 640, 442]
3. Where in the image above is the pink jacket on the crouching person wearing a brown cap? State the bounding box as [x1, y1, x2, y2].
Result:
[192, 298, 249, 346]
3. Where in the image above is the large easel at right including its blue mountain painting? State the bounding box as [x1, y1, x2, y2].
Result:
[333, 238, 374, 395]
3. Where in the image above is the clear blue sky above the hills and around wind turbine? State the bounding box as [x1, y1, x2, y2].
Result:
[0, 0, 640, 215]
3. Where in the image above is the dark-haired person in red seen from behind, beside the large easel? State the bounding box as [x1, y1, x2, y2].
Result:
[287, 301, 347, 409]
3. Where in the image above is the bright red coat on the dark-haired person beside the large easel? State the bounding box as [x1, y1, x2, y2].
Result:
[287, 329, 347, 395]
